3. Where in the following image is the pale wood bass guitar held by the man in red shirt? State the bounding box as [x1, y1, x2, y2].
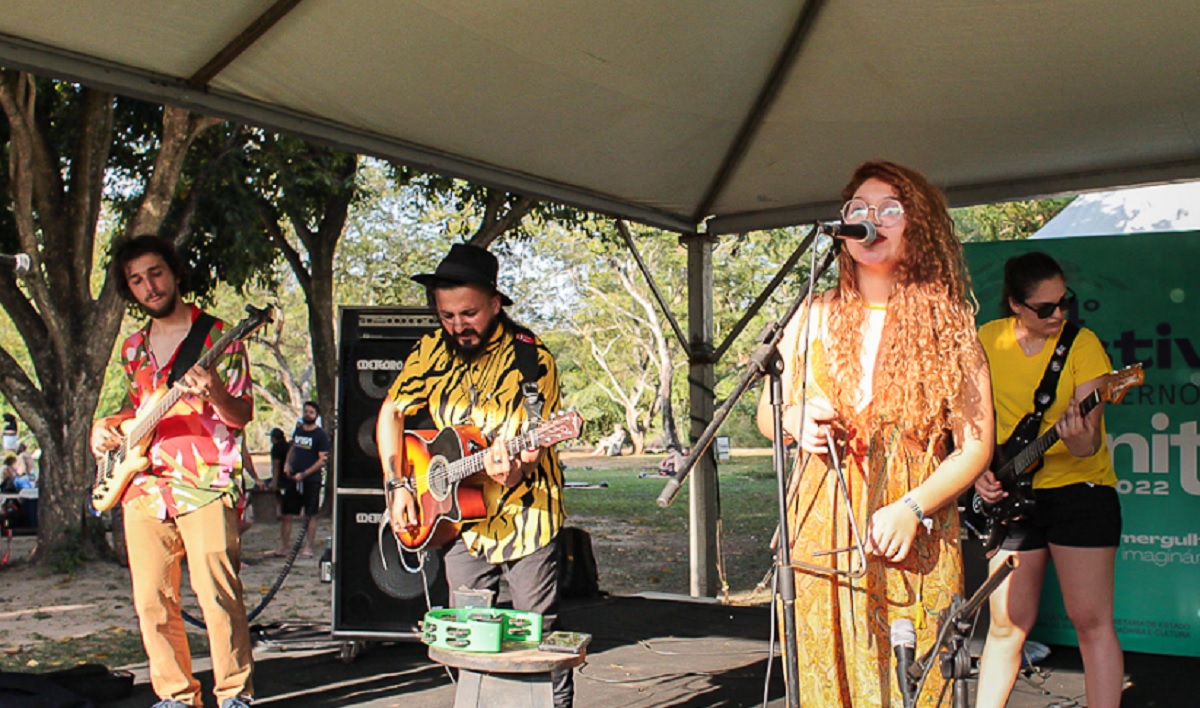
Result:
[91, 305, 271, 511]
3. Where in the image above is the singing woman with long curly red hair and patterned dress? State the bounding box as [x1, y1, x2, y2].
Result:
[758, 162, 994, 708]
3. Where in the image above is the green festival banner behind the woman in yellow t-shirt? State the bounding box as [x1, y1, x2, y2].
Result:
[966, 232, 1200, 656]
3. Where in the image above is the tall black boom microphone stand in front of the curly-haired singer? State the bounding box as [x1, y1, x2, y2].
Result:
[658, 229, 838, 708]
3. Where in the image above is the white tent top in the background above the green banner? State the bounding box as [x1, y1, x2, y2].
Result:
[1030, 182, 1200, 239]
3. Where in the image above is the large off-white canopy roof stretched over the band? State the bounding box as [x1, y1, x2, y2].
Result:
[0, 0, 1200, 233]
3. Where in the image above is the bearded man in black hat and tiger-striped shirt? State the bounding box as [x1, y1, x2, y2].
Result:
[376, 244, 574, 706]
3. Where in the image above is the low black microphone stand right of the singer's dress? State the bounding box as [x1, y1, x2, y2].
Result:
[901, 553, 1020, 708]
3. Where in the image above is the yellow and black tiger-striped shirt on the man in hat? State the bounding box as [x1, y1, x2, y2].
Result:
[389, 323, 566, 563]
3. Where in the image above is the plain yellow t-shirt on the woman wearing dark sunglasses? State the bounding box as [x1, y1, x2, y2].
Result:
[979, 317, 1117, 490]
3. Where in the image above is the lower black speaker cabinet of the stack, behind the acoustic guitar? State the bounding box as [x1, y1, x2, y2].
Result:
[332, 491, 449, 638]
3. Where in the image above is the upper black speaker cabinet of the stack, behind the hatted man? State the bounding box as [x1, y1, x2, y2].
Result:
[334, 307, 438, 491]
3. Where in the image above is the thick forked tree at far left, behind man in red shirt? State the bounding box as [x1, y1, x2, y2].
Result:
[0, 76, 217, 563]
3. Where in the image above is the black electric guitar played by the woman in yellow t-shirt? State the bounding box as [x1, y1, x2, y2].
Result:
[962, 364, 1146, 558]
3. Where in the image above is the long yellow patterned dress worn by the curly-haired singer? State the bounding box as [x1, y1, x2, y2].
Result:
[787, 341, 962, 708]
